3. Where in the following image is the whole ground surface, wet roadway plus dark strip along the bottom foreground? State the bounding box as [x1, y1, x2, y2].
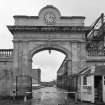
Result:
[0, 87, 104, 105]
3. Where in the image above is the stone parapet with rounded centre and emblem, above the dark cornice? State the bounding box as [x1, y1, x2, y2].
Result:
[14, 5, 85, 26]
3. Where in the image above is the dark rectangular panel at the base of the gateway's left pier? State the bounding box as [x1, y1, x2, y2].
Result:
[16, 75, 32, 98]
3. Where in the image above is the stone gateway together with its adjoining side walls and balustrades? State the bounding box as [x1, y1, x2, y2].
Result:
[0, 5, 105, 96]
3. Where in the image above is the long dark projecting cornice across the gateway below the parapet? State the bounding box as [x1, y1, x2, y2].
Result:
[7, 25, 89, 34]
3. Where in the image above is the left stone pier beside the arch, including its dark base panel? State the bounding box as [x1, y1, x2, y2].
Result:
[16, 41, 32, 97]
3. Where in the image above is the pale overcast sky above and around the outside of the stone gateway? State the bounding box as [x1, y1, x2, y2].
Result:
[0, 0, 105, 81]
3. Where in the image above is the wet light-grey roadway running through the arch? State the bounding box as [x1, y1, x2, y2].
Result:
[32, 87, 67, 105]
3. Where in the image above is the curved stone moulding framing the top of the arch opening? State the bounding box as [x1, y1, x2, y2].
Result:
[29, 44, 72, 74]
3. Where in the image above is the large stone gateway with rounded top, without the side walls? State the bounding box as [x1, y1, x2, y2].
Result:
[8, 6, 87, 95]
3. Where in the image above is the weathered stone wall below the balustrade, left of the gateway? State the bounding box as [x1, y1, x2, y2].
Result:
[0, 59, 13, 96]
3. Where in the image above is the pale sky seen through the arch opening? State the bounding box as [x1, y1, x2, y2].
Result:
[32, 50, 65, 81]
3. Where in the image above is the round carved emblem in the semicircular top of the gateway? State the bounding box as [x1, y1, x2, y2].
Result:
[44, 13, 56, 25]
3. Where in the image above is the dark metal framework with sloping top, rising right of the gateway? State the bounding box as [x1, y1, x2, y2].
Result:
[86, 13, 105, 53]
